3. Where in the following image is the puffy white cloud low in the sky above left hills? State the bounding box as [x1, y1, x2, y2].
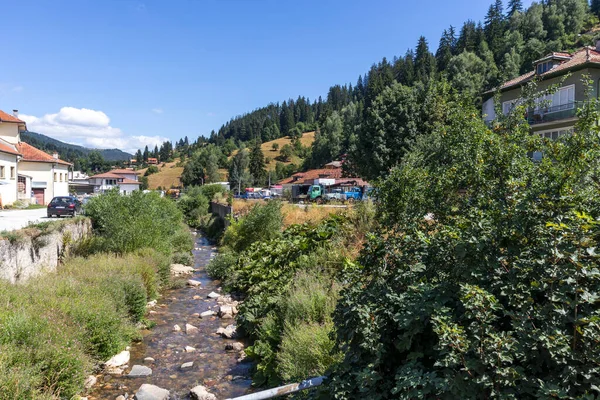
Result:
[19, 107, 168, 153]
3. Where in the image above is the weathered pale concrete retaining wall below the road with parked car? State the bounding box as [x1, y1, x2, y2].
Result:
[0, 219, 92, 283]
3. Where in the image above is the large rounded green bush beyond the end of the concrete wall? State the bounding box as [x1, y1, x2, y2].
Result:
[86, 191, 189, 254]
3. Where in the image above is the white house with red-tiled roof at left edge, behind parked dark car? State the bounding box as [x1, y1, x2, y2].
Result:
[0, 110, 71, 207]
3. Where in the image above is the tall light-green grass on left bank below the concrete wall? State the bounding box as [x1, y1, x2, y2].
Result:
[0, 250, 169, 400]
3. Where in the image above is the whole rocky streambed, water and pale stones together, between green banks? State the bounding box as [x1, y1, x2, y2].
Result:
[88, 234, 251, 400]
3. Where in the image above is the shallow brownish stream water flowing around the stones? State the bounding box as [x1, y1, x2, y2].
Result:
[88, 233, 252, 400]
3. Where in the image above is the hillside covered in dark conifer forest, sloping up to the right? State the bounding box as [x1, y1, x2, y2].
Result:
[151, 0, 600, 185]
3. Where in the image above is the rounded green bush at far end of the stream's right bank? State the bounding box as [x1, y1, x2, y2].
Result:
[222, 201, 283, 252]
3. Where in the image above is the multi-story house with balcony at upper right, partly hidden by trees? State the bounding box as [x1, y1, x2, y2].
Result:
[483, 42, 600, 139]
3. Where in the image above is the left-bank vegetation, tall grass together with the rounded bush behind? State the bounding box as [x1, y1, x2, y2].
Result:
[0, 192, 193, 400]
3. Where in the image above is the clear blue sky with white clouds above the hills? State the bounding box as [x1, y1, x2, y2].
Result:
[0, 0, 531, 151]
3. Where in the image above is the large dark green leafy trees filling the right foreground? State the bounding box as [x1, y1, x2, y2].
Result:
[330, 96, 600, 399]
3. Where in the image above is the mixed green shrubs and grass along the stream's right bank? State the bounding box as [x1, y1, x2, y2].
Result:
[208, 201, 373, 386]
